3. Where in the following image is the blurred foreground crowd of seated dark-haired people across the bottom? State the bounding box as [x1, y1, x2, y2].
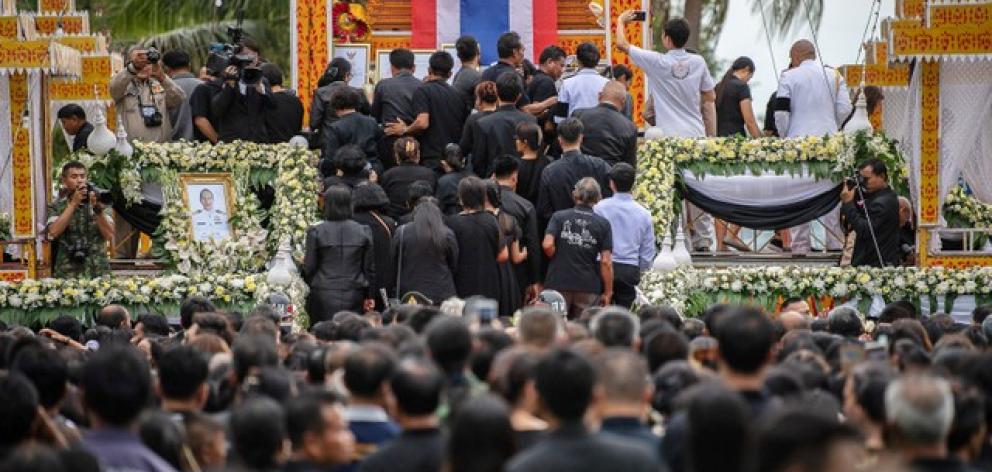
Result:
[0, 294, 992, 472]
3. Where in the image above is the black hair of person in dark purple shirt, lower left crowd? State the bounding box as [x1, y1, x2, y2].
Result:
[82, 345, 151, 427]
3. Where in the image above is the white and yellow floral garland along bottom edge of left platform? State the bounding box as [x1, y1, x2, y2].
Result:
[0, 273, 306, 325]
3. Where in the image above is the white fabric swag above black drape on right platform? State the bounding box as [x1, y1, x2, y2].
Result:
[682, 170, 837, 206]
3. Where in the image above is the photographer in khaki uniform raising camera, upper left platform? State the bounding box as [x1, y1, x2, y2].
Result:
[110, 46, 186, 143]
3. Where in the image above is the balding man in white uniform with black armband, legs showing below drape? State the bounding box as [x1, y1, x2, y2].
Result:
[775, 39, 851, 255]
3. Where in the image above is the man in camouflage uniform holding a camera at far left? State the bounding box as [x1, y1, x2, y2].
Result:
[45, 161, 114, 278]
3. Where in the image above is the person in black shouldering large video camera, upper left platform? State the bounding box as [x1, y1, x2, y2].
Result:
[210, 47, 275, 143]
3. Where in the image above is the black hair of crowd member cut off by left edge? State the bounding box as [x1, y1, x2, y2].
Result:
[0, 372, 38, 451]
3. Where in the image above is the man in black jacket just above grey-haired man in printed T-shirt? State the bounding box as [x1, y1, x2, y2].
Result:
[537, 118, 611, 221]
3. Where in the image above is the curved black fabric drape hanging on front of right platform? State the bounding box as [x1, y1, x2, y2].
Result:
[682, 184, 843, 230]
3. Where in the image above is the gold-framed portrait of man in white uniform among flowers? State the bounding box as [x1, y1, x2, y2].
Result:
[179, 173, 235, 241]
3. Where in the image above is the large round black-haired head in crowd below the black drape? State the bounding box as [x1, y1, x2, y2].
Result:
[713, 307, 775, 374]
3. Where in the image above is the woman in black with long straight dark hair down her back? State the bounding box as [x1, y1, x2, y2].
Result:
[393, 197, 459, 305]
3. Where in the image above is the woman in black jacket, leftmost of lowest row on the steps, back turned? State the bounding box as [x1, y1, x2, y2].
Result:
[303, 185, 375, 323]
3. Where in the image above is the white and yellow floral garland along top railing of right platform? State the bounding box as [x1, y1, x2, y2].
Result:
[635, 131, 909, 234]
